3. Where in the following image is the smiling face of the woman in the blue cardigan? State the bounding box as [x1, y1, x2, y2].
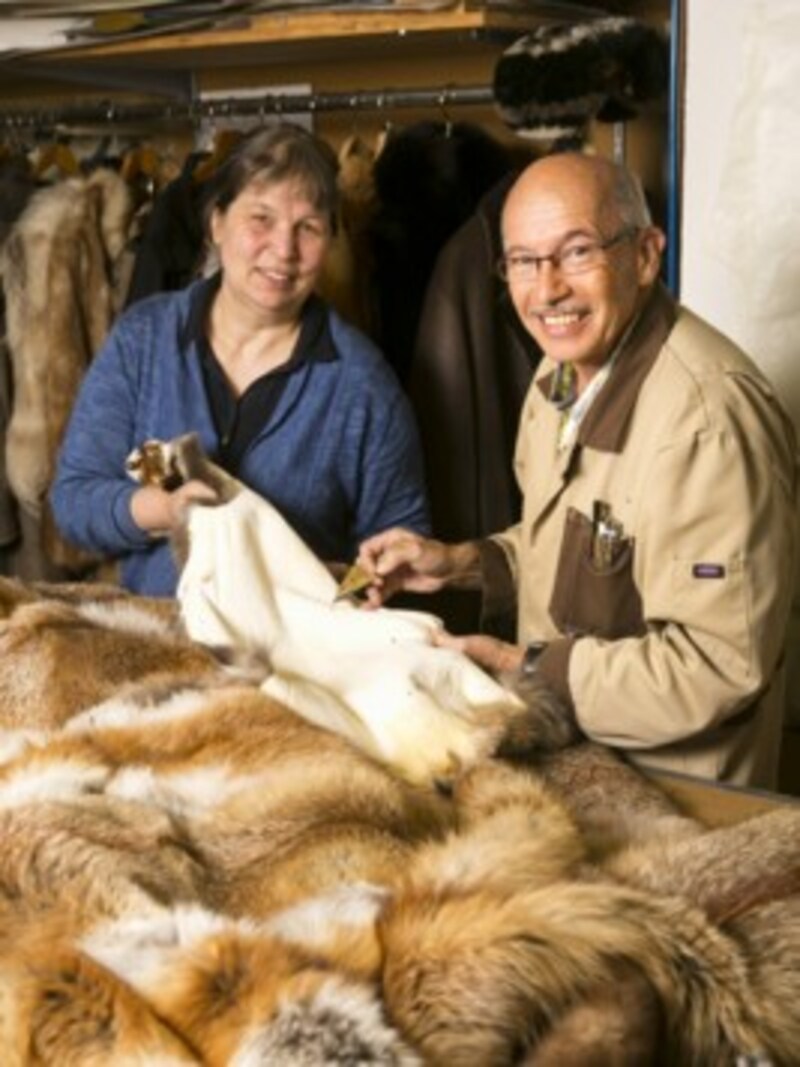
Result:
[211, 179, 332, 321]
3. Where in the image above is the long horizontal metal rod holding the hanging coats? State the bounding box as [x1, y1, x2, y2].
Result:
[0, 85, 494, 134]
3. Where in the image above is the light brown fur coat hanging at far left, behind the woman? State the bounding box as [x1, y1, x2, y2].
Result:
[0, 170, 132, 573]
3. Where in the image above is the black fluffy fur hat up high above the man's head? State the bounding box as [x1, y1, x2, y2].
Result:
[494, 18, 669, 142]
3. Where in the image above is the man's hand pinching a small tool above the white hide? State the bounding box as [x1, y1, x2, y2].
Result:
[358, 528, 480, 607]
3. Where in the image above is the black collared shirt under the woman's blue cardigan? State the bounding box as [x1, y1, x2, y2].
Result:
[197, 285, 336, 474]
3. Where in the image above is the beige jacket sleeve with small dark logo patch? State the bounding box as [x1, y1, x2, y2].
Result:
[569, 373, 797, 749]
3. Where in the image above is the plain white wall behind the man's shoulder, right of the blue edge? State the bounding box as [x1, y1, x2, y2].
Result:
[681, 0, 800, 723]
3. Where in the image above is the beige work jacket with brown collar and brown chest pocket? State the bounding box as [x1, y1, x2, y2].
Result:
[495, 287, 798, 787]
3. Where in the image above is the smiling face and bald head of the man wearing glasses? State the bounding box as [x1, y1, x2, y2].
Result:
[502, 156, 663, 388]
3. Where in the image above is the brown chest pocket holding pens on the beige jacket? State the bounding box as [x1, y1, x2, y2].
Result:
[549, 508, 645, 639]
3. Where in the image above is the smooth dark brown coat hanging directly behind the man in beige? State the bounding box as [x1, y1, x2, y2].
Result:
[409, 178, 541, 640]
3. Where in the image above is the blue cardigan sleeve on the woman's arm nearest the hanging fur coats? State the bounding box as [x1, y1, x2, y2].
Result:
[50, 317, 151, 555]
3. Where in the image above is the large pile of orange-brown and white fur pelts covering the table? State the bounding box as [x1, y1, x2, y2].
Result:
[0, 580, 800, 1067]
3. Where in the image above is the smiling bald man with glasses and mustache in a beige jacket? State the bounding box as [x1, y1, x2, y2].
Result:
[359, 154, 797, 787]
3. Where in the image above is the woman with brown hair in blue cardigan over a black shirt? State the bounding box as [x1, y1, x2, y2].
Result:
[51, 125, 428, 595]
